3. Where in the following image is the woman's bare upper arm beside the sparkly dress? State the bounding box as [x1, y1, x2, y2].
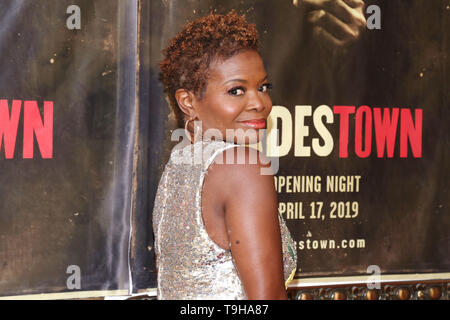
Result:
[214, 147, 287, 300]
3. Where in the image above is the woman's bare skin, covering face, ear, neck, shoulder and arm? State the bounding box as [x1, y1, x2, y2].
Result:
[176, 51, 287, 300]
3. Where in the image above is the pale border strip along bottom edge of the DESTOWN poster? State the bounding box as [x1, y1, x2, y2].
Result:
[289, 273, 450, 288]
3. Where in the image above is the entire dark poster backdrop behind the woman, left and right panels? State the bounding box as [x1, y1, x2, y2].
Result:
[0, 0, 450, 298]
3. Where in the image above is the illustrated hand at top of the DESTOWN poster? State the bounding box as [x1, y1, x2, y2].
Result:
[294, 0, 366, 53]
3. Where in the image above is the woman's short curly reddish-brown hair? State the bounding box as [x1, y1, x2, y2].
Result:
[159, 10, 259, 127]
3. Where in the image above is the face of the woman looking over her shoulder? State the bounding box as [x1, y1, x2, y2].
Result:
[193, 50, 272, 144]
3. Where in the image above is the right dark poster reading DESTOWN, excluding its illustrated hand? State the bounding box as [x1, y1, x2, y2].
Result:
[149, 0, 450, 282]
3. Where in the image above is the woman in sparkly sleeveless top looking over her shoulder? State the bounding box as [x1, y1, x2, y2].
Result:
[153, 11, 296, 299]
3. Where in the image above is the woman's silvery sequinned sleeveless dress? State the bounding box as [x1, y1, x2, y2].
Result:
[153, 140, 297, 300]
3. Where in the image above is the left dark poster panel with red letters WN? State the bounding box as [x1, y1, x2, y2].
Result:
[0, 0, 138, 298]
